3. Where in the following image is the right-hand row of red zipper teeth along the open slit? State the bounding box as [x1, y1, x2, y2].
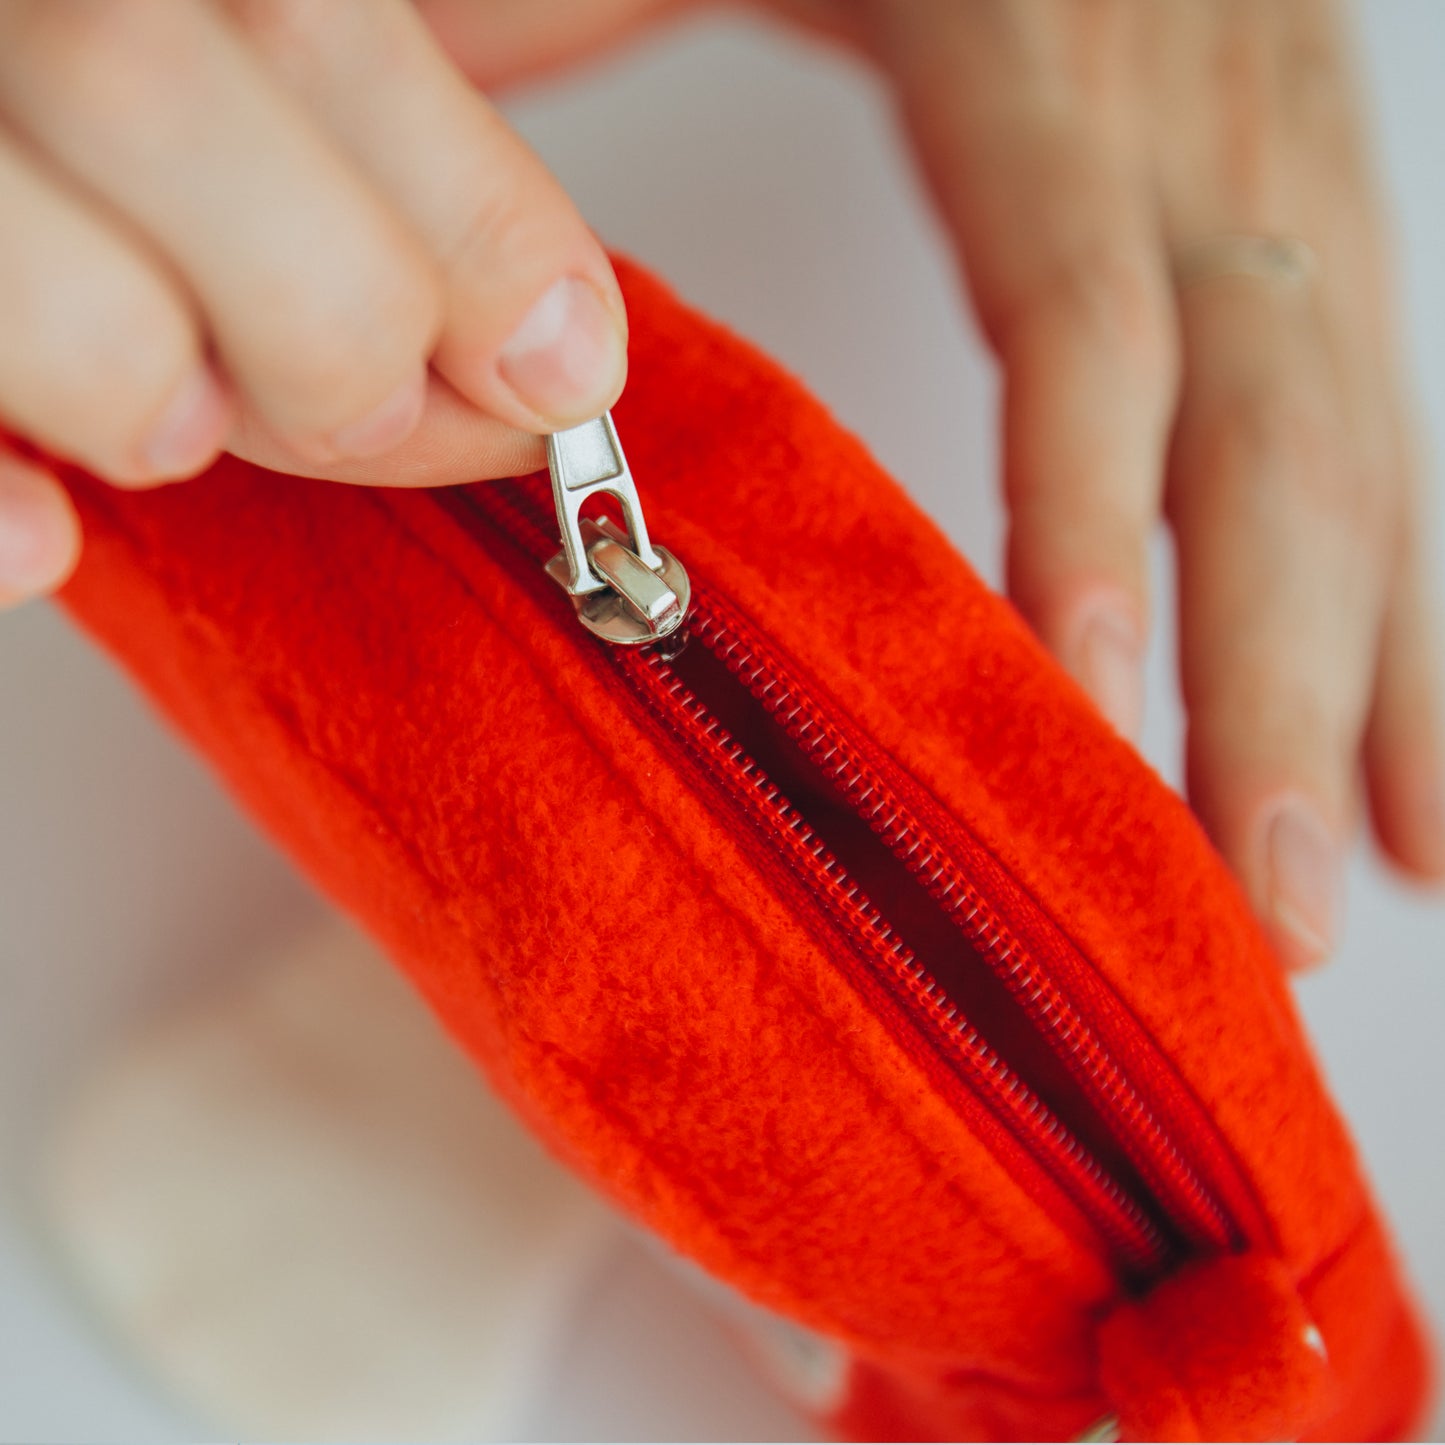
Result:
[694, 598, 1237, 1248]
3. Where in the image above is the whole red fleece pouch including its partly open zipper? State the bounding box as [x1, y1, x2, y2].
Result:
[56, 266, 1428, 1439]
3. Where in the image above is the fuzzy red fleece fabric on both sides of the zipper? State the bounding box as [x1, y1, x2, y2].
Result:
[53, 254, 1426, 1438]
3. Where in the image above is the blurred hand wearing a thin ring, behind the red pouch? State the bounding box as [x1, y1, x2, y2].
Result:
[423, 0, 1445, 965]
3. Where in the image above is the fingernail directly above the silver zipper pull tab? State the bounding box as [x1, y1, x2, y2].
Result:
[497, 276, 626, 426]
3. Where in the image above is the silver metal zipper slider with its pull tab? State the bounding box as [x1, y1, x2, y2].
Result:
[546, 412, 692, 644]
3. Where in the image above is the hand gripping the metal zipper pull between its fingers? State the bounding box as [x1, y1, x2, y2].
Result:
[0, 0, 626, 604]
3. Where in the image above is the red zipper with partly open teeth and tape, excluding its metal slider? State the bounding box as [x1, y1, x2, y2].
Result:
[432, 483, 1264, 1283]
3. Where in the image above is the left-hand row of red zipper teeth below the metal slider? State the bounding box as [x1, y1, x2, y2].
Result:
[620, 635, 1169, 1272]
